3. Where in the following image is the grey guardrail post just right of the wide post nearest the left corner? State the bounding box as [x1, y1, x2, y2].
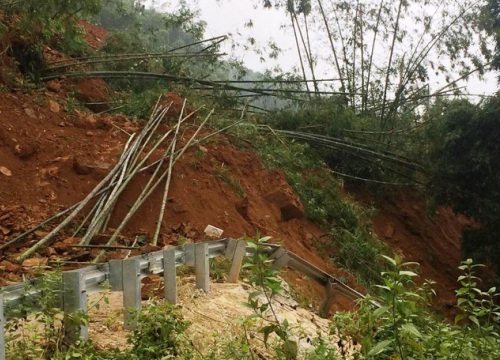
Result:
[122, 259, 141, 330]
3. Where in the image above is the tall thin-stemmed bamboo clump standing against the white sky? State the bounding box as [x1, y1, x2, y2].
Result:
[252, 0, 493, 131]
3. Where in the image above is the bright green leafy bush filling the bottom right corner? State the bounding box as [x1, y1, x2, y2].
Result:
[332, 257, 500, 359]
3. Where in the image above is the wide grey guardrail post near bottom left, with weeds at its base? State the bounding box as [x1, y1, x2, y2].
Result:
[62, 270, 89, 343]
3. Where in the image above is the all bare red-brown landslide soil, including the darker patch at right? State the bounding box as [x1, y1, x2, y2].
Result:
[0, 19, 469, 320]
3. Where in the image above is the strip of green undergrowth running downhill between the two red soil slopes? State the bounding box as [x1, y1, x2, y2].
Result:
[230, 126, 387, 285]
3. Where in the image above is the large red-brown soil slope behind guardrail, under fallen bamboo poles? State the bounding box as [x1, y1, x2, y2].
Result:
[0, 87, 358, 316]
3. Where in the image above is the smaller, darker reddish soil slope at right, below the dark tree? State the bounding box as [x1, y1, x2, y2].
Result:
[358, 193, 472, 315]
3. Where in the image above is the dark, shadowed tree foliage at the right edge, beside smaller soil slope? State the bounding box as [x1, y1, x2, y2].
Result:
[430, 94, 500, 268]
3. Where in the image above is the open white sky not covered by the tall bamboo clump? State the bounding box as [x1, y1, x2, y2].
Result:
[146, 0, 499, 94]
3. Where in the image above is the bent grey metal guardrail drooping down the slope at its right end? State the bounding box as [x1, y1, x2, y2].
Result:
[0, 239, 372, 360]
